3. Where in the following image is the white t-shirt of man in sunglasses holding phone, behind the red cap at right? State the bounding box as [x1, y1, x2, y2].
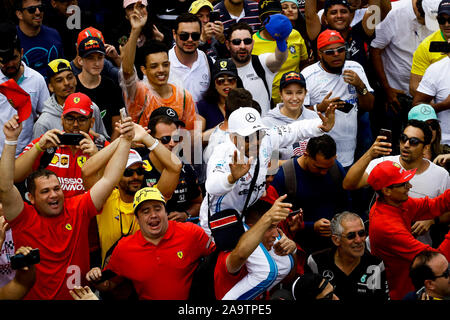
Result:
[366, 155, 450, 246]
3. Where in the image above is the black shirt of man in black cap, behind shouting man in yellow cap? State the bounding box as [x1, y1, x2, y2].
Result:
[142, 155, 201, 213]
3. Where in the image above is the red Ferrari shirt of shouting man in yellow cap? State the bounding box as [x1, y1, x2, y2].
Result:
[106, 221, 215, 300]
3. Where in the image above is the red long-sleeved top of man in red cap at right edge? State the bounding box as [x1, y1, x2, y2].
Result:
[369, 190, 450, 300]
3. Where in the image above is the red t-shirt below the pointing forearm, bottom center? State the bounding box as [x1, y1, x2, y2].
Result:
[214, 251, 248, 300]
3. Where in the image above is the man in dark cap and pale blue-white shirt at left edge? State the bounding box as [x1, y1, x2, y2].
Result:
[0, 23, 49, 156]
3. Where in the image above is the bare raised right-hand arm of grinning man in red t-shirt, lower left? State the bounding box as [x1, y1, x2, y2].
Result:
[90, 117, 134, 210]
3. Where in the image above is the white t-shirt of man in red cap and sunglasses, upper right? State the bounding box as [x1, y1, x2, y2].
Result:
[302, 60, 373, 167]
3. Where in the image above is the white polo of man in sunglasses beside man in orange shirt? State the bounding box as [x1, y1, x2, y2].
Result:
[168, 47, 211, 104]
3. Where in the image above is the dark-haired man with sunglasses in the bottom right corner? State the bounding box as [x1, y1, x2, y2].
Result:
[403, 250, 450, 300]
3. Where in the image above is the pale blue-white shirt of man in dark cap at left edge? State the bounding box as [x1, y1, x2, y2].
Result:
[0, 62, 50, 157]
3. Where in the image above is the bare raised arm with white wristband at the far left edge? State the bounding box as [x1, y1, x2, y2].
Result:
[0, 115, 23, 221]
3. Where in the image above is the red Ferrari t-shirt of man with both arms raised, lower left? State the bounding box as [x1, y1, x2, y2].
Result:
[8, 192, 100, 300]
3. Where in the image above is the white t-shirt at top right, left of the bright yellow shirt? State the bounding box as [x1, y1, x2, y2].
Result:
[370, 1, 433, 94]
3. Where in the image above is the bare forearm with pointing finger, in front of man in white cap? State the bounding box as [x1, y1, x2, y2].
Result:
[226, 195, 292, 273]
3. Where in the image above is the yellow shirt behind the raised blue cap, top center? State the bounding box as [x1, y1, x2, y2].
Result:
[252, 29, 308, 104]
